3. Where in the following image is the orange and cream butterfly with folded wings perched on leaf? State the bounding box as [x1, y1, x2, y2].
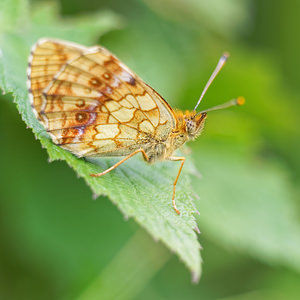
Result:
[27, 39, 244, 214]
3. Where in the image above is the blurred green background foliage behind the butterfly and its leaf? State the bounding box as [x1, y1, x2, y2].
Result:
[0, 0, 300, 300]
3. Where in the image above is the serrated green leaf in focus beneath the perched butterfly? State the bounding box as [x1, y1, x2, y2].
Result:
[0, 0, 201, 279]
